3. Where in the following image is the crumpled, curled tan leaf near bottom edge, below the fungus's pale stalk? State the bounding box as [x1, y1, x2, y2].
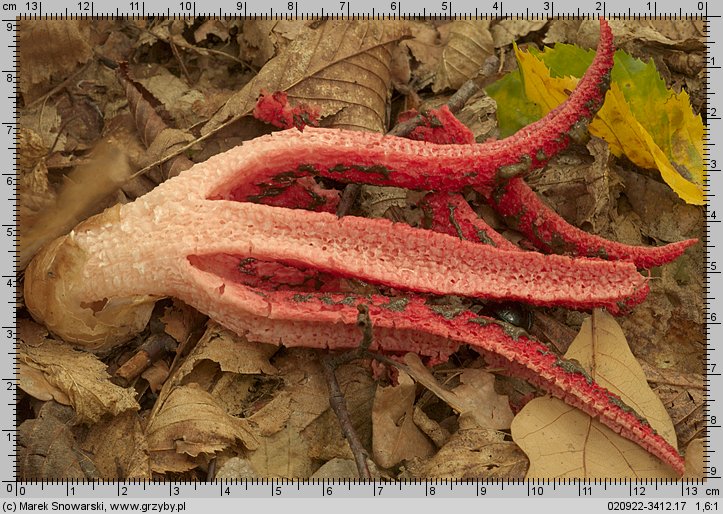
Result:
[146, 384, 259, 473]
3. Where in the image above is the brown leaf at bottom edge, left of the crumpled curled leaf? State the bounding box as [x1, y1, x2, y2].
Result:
[80, 412, 152, 480]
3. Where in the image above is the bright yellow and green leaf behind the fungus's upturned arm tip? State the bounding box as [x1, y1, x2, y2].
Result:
[488, 44, 706, 205]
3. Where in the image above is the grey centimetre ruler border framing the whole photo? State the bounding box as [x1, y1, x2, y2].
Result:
[0, 0, 723, 504]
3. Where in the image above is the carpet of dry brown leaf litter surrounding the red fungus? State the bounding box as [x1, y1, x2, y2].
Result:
[19, 20, 705, 479]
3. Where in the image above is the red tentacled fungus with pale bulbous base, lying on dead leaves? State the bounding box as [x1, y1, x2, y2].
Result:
[25, 20, 691, 473]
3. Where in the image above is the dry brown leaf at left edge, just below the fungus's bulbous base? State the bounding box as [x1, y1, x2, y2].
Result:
[18, 321, 139, 423]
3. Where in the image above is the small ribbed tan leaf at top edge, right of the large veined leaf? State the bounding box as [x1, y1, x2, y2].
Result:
[432, 20, 494, 93]
